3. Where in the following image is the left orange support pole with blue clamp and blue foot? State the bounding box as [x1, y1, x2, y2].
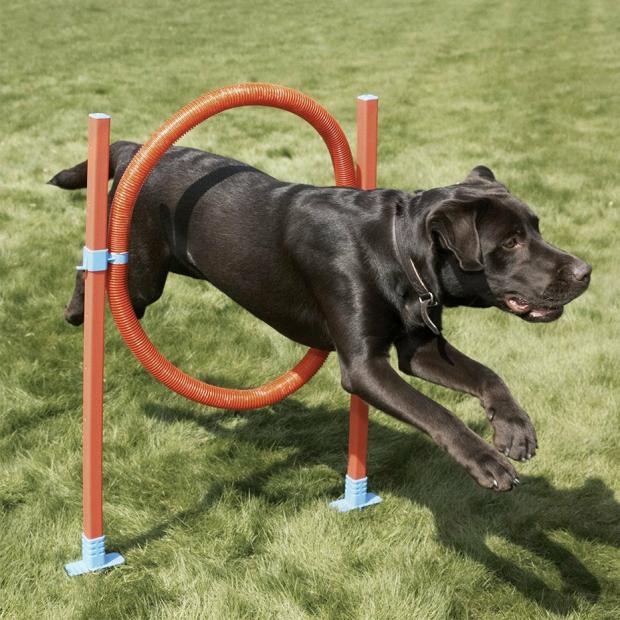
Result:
[65, 114, 125, 576]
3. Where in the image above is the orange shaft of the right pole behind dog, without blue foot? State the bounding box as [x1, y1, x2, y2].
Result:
[347, 95, 379, 480]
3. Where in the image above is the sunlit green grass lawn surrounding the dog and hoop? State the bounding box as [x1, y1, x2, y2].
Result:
[0, 0, 620, 620]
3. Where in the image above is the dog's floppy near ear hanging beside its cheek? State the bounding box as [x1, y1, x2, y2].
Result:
[426, 200, 484, 271]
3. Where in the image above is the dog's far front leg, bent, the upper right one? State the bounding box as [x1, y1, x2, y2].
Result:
[395, 330, 537, 461]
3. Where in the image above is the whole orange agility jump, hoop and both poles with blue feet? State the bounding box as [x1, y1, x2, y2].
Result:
[65, 83, 381, 575]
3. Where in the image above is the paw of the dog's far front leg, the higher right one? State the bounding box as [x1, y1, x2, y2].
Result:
[489, 403, 538, 461]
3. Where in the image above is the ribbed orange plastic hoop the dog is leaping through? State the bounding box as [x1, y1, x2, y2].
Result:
[108, 83, 356, 409]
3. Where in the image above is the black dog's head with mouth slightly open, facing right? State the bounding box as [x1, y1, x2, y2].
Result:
[420, 166, 592, 322]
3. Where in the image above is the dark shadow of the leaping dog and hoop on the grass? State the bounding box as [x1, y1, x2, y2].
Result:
[116, 398, 620, 615]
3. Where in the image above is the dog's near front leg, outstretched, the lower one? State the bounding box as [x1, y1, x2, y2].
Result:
[338, 349, 518, 491]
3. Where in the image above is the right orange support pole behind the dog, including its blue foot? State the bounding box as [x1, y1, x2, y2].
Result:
[330, 95, 381, 512]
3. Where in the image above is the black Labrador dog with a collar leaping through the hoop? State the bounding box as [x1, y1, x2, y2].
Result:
[50, 142, 591, 491]
